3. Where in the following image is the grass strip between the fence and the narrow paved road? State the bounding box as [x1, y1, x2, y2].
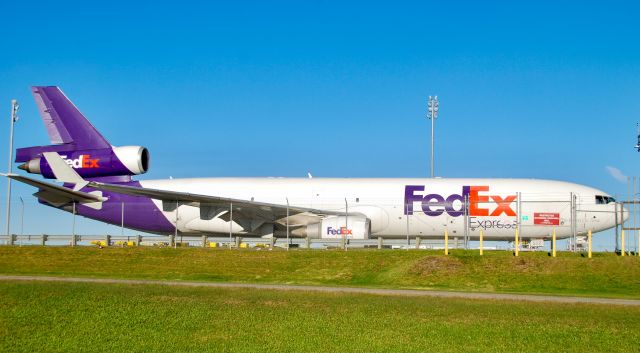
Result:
[0, 246, 640, 298]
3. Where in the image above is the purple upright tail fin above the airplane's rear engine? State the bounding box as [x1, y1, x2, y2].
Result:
[31, 86, 110, 149]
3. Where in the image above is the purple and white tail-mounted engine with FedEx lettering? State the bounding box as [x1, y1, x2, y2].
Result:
[18, 146, 149, 179]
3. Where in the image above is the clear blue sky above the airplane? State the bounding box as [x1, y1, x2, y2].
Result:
[0, 1, 640, 248]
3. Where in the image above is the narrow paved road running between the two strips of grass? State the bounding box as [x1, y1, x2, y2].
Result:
[0, 275, 640, 306]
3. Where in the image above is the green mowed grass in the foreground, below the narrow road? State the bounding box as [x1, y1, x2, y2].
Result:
[0, 281, 640, 352]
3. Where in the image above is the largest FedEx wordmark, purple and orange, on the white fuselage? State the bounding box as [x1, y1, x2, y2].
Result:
[404, 185, 517, 217]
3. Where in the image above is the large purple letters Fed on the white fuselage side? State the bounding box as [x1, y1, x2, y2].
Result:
[404, 185, 470, 217]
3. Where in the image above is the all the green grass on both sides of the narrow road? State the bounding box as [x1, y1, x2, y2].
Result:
[0, 246, 640, 352]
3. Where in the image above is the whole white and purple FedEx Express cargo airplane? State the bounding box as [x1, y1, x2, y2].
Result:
[5, 86, 628, 240]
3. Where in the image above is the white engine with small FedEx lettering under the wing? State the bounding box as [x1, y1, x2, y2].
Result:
[292, 216, 371, 239]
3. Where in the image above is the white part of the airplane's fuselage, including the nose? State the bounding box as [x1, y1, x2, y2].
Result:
[140, 178, 616, 240]
